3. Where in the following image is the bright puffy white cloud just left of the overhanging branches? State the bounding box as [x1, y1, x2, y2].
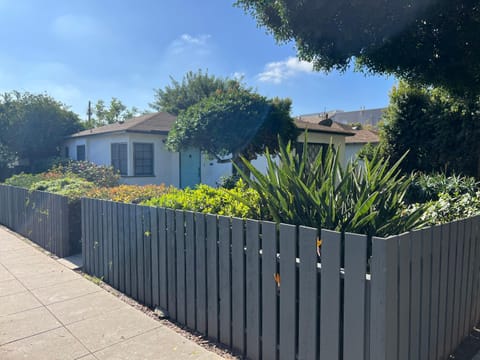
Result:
[257, 57, 313, 84]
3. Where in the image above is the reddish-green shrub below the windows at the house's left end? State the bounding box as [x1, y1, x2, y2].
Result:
[51, 160, 120, 187]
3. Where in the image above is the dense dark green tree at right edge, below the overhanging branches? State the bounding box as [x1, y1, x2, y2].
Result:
[380, 82, 480, 178]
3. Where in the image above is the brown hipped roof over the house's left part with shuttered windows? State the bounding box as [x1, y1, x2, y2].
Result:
[68, 112, 176, 138]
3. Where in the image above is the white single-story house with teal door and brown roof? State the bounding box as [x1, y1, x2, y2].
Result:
[64, 112, 355, 188]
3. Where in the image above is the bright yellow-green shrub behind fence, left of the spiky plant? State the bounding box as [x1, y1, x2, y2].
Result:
[142, 180, 262, 219]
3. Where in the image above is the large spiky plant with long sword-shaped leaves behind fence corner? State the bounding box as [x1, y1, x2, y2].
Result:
[237, 141, 424, 236]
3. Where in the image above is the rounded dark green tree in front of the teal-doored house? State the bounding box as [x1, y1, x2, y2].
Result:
[166, 88, 298, 169]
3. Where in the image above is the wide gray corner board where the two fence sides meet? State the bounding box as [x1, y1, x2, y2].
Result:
[370, 236, 398, 360]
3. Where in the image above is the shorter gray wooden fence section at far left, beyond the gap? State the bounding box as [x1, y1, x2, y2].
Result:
[0, 185, 81, 257]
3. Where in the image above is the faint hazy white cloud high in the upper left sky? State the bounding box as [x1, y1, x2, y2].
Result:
[51, 14, 107, 39]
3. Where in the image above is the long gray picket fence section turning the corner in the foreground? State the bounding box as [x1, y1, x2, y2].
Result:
[82, 199, 480, 360]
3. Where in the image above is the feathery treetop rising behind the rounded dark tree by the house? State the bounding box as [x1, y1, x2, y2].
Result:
[150, 70, 239, 115]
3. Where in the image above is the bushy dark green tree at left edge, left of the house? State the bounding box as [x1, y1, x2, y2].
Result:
[0, 91, 83, 171]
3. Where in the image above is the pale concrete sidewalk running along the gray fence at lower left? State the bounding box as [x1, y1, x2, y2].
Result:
[0, 227, 221, 360]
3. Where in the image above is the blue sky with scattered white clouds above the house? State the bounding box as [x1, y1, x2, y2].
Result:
[0, 0, 396, 119]
